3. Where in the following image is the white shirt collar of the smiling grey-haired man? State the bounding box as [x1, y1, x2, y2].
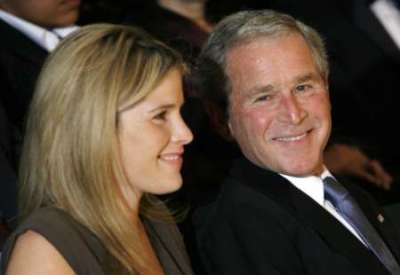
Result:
[280, 167, 333, 206]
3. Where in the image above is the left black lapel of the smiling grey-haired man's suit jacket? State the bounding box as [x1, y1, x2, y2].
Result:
[233, 160, 388, 274]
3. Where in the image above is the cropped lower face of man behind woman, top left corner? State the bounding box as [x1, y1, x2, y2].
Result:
[1, 0, 80, 28]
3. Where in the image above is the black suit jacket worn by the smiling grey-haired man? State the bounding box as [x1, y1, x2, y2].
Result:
[193, 159, 400, 275]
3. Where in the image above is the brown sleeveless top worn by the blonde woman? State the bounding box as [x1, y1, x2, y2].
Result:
[0, 207, 193, 275]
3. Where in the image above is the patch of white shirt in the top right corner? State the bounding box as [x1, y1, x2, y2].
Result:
[370, 0, 400, 49]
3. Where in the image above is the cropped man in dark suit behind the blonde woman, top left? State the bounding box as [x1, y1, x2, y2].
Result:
[0, 0, 80, 223]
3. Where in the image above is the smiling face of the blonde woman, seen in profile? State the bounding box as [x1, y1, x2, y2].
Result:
[118, 69, 193, 203]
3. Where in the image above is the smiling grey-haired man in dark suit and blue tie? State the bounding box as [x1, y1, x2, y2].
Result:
[193, 10, 400, 275]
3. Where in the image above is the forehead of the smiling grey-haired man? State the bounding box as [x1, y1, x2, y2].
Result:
[226, 34, 321, 96]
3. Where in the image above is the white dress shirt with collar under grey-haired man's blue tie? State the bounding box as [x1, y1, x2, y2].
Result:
[280, 168, 365, 245]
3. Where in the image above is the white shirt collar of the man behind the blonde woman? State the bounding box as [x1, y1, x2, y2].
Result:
[0, 10, 78, 52]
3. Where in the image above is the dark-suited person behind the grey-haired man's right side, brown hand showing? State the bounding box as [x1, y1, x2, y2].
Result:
[228, 0, 400, 198]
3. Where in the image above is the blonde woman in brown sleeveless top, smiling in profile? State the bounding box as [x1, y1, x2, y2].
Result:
[1, 24, 193, 275]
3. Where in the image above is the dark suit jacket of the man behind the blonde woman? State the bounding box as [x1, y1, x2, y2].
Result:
[0, 20, 48, 218]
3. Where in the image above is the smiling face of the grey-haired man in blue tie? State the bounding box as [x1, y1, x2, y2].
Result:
[226, 34, 331, 176]
